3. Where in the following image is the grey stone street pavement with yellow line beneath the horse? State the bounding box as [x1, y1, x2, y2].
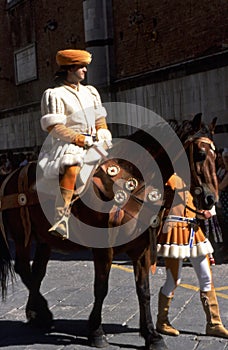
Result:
[0, 252, 228, 350]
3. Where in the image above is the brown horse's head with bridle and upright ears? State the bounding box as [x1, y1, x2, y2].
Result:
[177, 113, 218, 210]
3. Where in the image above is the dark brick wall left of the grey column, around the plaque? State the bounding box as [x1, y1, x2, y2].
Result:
[0, 0, 85, 110]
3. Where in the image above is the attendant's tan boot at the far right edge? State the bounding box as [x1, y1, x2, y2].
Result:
[200, 287, 228, 338]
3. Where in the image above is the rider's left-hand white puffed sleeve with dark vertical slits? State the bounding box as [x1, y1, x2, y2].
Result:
[40, 89, 66, 131]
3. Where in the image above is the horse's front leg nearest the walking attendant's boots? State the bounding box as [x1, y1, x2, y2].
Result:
[133, 249, 168, 350]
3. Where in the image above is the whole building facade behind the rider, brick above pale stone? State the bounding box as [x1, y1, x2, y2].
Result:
[0, 0, 228, 152]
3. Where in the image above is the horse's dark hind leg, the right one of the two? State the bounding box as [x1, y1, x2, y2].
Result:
[26, 242, 53, 328]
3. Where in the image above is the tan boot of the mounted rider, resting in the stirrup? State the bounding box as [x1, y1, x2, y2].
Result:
[49, 187, 74, 239]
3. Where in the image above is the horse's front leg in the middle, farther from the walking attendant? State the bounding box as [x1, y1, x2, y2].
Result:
[89, 248, 113, 348]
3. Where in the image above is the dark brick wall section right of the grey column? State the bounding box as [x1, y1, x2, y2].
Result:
[113, 0, 228, 78]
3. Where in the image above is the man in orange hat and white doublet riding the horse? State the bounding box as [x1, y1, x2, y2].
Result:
[41, 49, 112, 239]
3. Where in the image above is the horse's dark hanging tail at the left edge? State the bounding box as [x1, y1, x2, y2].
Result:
[0, 230, 15, 300]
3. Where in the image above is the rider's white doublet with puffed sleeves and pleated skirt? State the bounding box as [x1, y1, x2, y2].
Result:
[39, 84, 107, 178]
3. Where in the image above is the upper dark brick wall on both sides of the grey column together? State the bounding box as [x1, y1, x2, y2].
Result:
[0, 0, 228, 109]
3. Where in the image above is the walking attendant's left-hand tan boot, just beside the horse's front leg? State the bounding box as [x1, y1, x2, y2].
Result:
[156, 289, 180, 336]
